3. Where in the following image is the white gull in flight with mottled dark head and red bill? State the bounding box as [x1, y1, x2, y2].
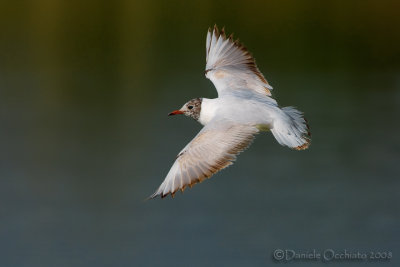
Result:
[150, 26, 311, 198]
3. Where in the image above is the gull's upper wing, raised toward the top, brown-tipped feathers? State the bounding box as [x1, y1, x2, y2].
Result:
[205, 26, 272, 96]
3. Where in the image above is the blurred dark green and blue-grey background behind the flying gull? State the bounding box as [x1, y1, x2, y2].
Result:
[0, 0, 400, 266]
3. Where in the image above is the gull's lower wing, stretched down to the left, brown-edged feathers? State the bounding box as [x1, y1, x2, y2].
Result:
[150, 120, 259, 198]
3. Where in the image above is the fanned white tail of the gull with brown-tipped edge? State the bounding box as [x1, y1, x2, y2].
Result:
[271, 107, 311, 150]
